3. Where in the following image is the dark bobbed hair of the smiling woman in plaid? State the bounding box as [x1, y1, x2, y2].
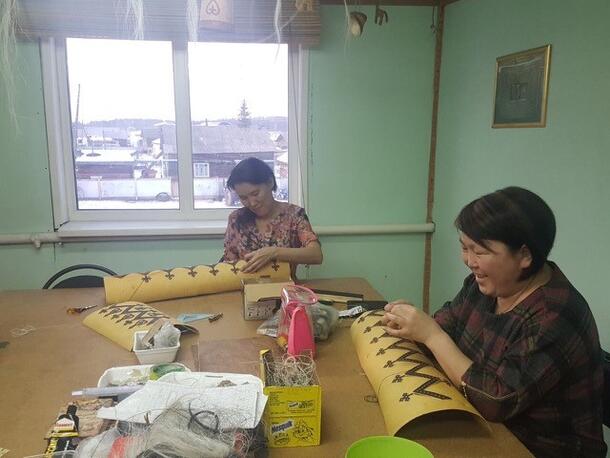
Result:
[455, 186, 556, 280]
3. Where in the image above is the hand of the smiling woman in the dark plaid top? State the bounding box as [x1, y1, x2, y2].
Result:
[381, 299, 443, 345]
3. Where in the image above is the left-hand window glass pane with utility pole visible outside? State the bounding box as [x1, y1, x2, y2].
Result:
[67, 38, 179, 210]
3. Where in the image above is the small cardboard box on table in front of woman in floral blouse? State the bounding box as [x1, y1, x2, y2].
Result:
[242, 280, 294, 320]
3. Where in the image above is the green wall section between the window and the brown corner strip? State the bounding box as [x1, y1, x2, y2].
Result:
[309, 6, 434, 300]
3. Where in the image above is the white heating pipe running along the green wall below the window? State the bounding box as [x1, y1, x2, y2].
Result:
[0, 223, 434, 248]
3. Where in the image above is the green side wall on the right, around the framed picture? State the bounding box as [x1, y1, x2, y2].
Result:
[431, 0, 610, 349]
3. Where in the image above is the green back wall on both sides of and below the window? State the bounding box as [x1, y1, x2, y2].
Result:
[0, 6, 434, 300]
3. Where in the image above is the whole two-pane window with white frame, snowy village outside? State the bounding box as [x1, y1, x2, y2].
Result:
[41, 38, 306, 227]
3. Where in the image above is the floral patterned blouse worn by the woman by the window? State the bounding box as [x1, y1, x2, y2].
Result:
[221, 204, 318, 262]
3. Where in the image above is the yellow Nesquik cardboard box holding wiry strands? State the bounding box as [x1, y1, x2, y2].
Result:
[261, 350, 322, 448]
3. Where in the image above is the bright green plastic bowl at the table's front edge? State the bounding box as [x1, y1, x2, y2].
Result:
[345, 436, 434, 458]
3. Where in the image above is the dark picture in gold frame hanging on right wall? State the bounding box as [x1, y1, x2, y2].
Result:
[492, 45, 551, 128]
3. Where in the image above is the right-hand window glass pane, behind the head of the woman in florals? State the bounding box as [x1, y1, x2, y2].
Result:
[188, 43, 288, 209]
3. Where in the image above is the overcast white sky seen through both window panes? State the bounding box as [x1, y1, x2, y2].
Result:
[67, 39, 288, 123]
